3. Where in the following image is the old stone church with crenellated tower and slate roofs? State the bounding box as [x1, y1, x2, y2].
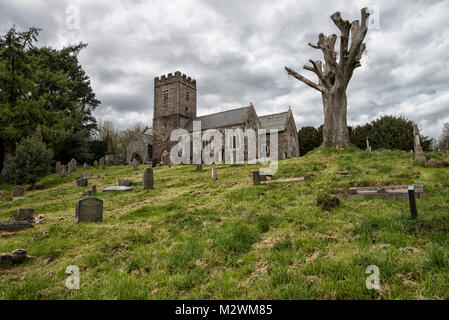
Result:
[152, 71, 299, 162]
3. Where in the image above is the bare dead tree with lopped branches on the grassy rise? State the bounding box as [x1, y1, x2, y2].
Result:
[285, 8, 369, 148]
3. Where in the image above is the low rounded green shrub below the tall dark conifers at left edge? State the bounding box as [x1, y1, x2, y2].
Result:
[2, 137, 53, 186]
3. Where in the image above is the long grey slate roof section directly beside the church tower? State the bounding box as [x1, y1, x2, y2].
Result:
[184, 107, 250, 132]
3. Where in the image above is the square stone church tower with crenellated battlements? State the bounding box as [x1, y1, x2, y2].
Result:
[153, 71, 196, 161]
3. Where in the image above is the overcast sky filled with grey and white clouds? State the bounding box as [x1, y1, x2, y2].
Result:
[0, 0, 449, 137]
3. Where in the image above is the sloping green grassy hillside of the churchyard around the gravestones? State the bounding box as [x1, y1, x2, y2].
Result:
[0, 148, 449, 299]
